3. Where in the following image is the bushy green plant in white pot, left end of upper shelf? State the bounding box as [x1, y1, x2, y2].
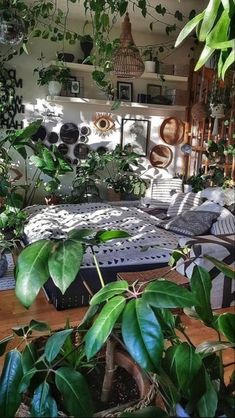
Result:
[34, 61, 71, 96]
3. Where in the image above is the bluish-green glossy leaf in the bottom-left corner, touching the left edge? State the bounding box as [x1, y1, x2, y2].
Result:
[0, 350, 23, 418]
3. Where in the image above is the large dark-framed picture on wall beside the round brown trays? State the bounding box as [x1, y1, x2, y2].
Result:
[121, 119, 150, 156]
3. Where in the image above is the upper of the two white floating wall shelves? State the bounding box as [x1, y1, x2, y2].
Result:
[48, 61, 188, 83]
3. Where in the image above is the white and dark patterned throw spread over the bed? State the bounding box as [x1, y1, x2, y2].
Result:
[24, 203, 180, 268]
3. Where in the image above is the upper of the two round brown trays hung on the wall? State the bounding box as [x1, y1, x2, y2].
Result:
[160, 117, 184, 145]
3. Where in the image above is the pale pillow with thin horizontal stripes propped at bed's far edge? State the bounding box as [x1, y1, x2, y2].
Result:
[150, 178, 183, 209]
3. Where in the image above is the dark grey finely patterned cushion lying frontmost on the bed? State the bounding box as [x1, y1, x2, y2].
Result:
[158, 210, 218, 237]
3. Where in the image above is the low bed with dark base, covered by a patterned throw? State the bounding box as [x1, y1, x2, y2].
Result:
[24, 203, 182, 310]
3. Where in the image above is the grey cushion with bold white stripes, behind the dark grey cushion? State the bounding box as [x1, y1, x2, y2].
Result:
[167, 192, 202, 218]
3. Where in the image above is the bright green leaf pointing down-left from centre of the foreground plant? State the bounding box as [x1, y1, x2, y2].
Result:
[85, 296, 126, 360]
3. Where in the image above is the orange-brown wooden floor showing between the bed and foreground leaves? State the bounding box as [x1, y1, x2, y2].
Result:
[0, 290, 234, 381]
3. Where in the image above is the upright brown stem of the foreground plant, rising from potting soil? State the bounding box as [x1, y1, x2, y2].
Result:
[101, 338, 115, 402]
